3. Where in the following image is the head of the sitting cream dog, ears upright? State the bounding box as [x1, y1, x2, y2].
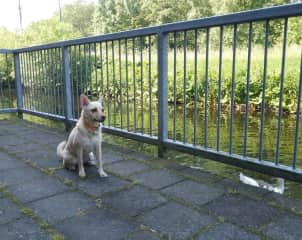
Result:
[80, 94, 106, 123]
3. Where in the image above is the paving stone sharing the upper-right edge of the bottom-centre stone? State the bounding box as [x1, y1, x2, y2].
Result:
[162, 180, 224, 205]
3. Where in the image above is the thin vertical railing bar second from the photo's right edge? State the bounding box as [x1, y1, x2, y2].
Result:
[275, 17, 288, 165]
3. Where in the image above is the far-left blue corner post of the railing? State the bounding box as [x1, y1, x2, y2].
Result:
[14, 53, 23, 119]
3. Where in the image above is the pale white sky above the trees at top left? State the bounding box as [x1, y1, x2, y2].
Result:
[0, 0, 96, 31]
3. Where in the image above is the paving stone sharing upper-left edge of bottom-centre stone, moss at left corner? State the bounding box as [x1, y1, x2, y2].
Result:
[103, 186, 167, 217]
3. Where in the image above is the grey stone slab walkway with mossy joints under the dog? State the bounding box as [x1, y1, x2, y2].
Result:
[0, 120, 302, 240]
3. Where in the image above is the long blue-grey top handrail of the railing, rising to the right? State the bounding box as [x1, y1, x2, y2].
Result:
[4, 3, 302, 53]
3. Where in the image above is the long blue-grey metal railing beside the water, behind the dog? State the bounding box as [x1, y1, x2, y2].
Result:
[0, 4, 302, 181]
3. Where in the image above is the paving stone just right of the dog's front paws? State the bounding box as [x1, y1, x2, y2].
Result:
[106, 160, 148, 176]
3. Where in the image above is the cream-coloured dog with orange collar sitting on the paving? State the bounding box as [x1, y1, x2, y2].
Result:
[57, 95, 107, 178]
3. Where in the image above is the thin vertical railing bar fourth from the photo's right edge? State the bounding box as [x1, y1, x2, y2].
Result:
[243, 22, 253, 157]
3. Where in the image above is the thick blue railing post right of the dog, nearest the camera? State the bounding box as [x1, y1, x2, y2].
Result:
[157, 32, 168, 157]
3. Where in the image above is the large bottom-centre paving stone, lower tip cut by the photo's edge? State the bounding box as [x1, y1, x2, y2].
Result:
[139, 202, 214, 239]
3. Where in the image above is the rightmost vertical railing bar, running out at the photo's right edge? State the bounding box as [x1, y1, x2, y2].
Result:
[292, 50, 302, 169]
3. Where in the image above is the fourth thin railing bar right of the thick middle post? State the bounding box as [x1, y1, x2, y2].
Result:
[204, 28, 210, 148]
